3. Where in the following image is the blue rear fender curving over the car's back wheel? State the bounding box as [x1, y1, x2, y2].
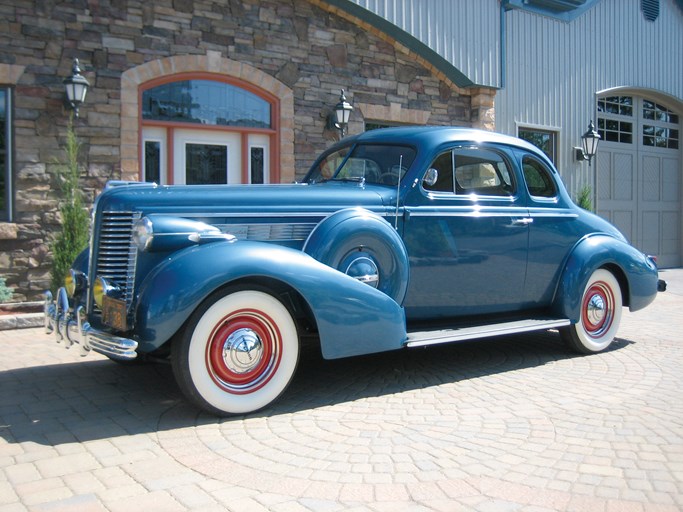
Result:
[554, 235, 658, 322]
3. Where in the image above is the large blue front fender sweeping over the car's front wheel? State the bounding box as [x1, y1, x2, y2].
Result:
[136, 241, 406, 359]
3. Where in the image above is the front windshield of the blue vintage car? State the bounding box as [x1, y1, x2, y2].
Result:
[306, 144, 415, 185]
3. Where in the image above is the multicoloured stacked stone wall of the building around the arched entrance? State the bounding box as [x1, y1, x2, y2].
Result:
[0, 0, 493, 300]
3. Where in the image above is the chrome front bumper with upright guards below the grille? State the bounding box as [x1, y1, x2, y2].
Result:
[44, 288, 138, 361]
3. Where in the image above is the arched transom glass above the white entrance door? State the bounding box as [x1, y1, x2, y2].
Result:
[142, 80, 272, 128]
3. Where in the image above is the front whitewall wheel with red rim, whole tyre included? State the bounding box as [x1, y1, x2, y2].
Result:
[171, 289, 299, 415]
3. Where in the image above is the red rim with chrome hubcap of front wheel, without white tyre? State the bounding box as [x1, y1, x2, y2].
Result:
[205, 309, 282, 395]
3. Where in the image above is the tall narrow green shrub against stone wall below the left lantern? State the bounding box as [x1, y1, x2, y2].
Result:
[51, 121, 90, 292]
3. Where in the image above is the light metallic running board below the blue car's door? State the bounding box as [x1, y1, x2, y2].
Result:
[405, 318, 571, 347]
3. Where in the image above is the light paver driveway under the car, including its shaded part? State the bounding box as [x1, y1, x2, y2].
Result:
[0, 270, 683, 512]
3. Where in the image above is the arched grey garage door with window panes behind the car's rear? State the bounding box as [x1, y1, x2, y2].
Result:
[596, 96, 683, 268]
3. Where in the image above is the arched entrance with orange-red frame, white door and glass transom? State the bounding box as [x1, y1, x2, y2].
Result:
[140, 73, 278, 184]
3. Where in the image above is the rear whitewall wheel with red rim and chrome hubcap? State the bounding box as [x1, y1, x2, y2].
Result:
[560, 269, 622, 354]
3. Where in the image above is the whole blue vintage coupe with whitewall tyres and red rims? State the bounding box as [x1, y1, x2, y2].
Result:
[45, 127, 662, 414]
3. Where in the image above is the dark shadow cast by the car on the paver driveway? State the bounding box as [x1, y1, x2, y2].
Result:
[0, 332, 631, 446]
